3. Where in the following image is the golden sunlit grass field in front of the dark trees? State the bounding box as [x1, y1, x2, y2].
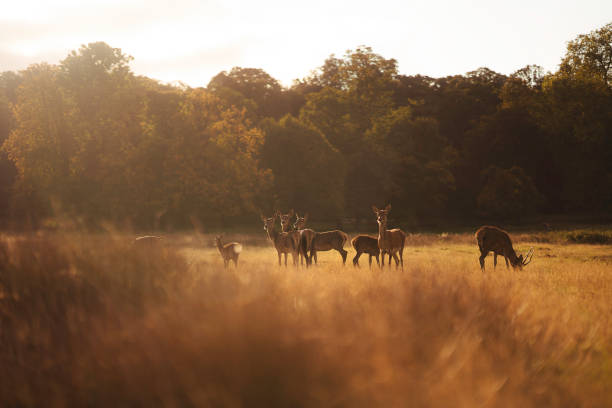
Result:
[0, 232, 612, 407]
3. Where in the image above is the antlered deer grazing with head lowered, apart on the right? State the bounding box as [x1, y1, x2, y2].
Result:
[476, 225, 533, 271]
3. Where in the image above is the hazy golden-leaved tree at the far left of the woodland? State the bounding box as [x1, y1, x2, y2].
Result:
[3, 64, 75, 223]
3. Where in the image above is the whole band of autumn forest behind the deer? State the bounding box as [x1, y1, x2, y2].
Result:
[0, 23, 612, 230]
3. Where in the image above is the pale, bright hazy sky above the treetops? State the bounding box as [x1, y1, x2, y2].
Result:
[0, 0, 612, 86]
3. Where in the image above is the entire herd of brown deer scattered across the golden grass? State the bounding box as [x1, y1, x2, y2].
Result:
[133, 204, 533, 271]
